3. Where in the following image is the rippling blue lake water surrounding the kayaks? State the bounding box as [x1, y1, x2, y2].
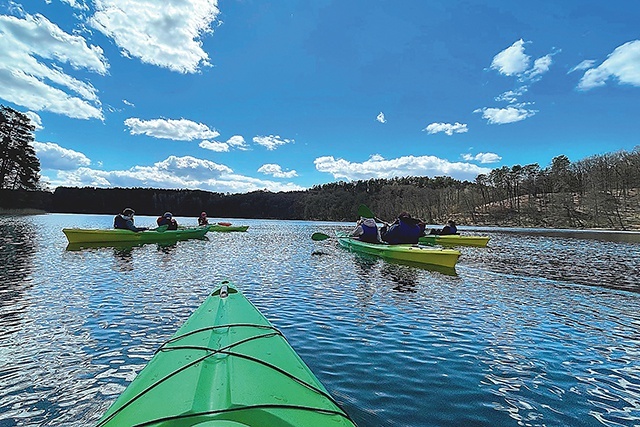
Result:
[0, 214, 640, 427]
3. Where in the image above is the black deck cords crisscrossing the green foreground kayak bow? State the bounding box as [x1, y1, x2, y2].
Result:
[97, 323, 355, 427]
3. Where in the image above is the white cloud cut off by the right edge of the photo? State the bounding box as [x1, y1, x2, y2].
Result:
[578, 40, 640, 90]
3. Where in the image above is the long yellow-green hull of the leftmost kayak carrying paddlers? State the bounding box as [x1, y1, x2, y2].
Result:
[62, 227, 209, 244]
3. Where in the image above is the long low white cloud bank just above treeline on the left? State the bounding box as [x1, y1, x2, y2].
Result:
[48, 156, 304, 193]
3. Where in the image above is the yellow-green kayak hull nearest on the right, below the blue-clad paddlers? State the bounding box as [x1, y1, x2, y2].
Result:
[338, 234, 460, 268]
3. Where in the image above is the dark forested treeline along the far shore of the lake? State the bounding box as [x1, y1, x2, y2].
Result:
[0, 147, 640, 230]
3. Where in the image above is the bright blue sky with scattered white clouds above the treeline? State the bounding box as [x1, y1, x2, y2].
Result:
[0, 0, 640, 193]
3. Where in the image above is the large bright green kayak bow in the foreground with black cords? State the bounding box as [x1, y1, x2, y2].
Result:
[98, 281, 355, 427]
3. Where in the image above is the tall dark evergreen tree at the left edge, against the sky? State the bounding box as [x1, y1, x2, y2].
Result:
[0, 105, 40, 190]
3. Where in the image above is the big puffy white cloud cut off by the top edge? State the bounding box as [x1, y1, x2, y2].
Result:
[89, 0, 220, 73]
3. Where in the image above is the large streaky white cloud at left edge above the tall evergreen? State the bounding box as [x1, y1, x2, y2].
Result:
[0, 14, 109, 120]
